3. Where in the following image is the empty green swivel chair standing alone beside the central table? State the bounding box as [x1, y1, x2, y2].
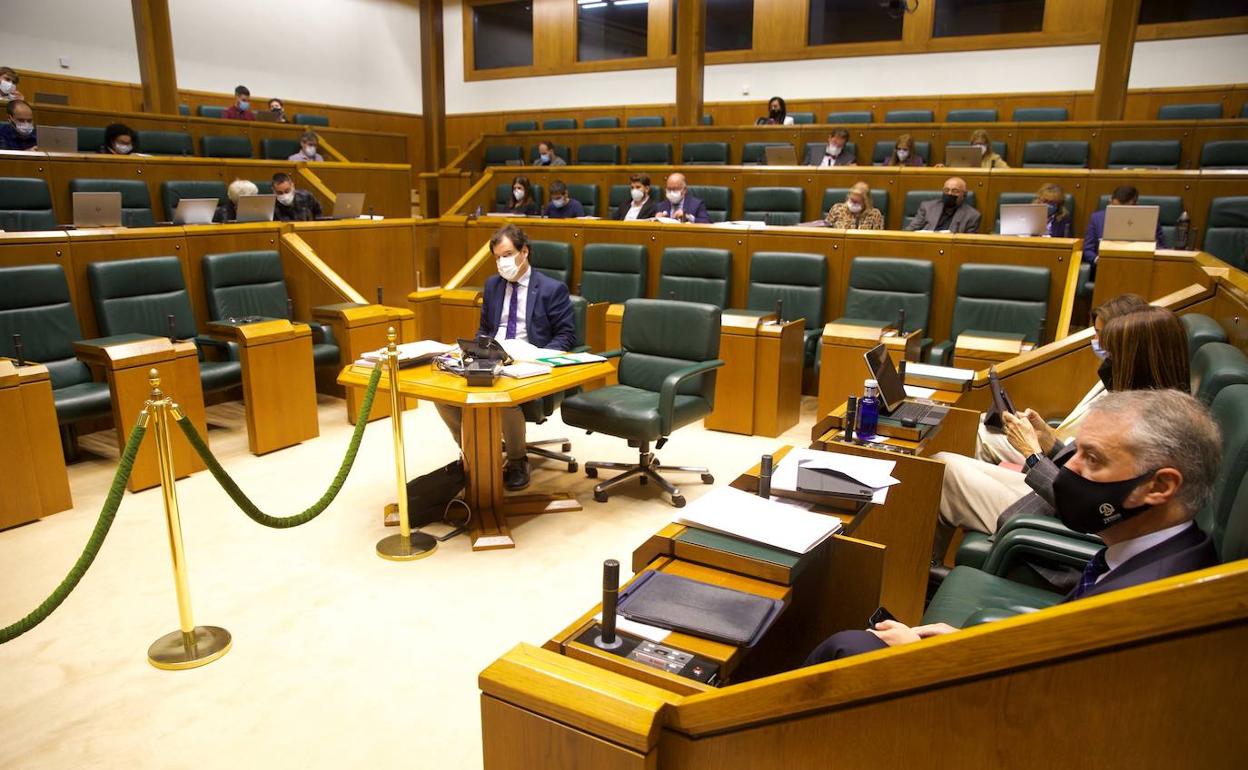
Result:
[563, 300, 724, 508]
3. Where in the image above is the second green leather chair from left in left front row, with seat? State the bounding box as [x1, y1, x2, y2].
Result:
[86, 257, 242, 393]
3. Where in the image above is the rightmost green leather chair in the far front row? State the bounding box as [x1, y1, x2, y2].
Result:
[927, 265, 1050, 366]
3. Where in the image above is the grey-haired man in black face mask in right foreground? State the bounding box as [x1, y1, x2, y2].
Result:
[806, 391, 1222, 665]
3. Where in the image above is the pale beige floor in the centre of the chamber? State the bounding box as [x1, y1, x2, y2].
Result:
[0, 397, 815, 770]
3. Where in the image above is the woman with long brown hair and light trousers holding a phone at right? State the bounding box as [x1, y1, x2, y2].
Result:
[935, 302, 1191, 550]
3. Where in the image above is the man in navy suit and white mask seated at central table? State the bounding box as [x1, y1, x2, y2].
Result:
[438, 225, 577, 490]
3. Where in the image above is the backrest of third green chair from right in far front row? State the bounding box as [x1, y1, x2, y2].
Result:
[745, 251, 827, 329]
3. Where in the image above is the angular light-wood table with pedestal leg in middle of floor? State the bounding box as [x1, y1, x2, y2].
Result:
[338, 362, 612, 550]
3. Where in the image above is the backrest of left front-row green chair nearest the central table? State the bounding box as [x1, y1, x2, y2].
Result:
[203, 251, 290, 321]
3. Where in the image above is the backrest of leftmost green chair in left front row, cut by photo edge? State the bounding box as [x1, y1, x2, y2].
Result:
[0, 265, 91, 388]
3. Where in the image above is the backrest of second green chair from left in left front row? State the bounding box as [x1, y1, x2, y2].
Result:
[86, 257, 196, 339]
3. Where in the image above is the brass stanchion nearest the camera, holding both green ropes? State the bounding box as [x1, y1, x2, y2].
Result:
[139, 369, 231, 671]
